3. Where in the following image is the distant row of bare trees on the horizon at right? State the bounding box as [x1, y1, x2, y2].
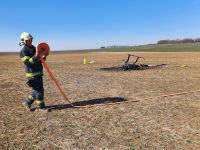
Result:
[157, 38, 200, 44]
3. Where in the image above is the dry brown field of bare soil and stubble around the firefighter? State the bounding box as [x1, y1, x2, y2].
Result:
[0, 52, 200, 150]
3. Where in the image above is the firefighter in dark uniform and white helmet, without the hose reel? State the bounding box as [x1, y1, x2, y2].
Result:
[20, 32, 46, 110]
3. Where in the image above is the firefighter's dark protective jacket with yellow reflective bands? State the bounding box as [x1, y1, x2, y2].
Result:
[20, 45, 43, 78]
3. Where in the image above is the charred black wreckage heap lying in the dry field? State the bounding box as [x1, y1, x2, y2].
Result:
[100, 54, 167, 71]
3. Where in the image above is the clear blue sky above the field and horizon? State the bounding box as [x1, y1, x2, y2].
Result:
[0, 0, 200, 51]
